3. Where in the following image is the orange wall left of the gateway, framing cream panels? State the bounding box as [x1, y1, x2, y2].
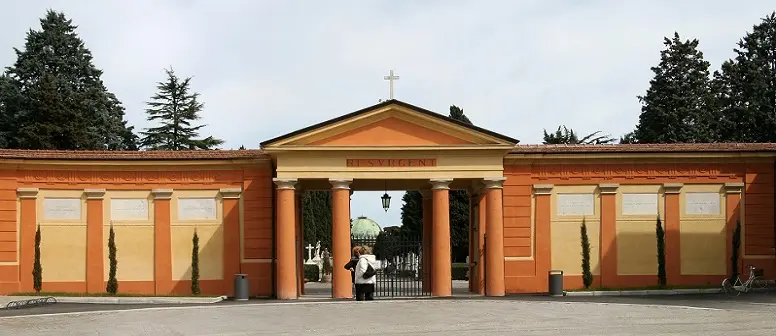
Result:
[0, 162, 272, 296]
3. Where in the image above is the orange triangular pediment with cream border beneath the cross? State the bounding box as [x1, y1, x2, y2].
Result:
[262, 100, 518, 149]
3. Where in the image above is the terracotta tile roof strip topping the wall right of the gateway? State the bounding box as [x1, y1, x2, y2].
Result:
[510, 143, 776, 154]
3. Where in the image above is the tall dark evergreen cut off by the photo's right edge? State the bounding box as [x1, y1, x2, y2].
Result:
[712, 12, 776, 142]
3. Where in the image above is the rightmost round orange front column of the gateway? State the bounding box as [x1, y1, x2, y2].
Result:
[484, 177, 506, 296]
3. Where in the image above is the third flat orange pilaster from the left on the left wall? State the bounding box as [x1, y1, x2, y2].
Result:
[151, 189, 172, 295]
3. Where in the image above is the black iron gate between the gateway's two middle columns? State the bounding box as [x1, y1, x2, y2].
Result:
[351, 232, 431, 298]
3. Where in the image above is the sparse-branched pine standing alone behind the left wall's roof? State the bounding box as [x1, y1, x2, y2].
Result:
[140, 69, 224, 150]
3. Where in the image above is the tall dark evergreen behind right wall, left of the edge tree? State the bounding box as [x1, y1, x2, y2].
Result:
[634, 33, 719, 143]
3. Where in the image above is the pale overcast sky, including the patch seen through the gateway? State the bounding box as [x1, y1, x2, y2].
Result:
[0, 0, 776, 226]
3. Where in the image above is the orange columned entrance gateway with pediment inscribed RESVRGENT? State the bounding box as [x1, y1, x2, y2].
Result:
[261, 99, 518, 299]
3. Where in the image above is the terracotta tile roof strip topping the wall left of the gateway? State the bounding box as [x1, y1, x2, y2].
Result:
[0, 149, 265, 160]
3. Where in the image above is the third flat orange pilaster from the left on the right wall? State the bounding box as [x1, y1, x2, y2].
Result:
[663, 183, 682, 285]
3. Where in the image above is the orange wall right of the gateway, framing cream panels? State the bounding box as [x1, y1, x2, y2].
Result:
[504, 163, 776, 293]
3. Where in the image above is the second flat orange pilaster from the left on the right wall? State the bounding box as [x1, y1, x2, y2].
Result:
[598, 183, 619, 288]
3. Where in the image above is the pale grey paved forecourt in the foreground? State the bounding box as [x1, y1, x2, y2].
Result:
[0, 298, 776, 336]
